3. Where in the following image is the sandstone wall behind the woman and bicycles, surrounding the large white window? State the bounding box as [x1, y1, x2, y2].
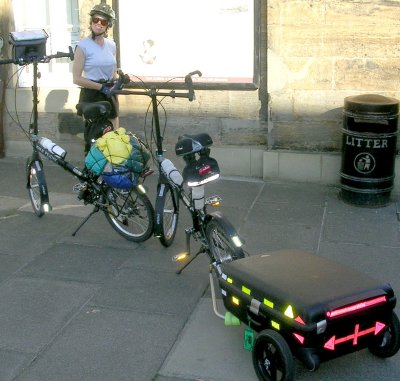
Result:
[4, 0, 400, 182]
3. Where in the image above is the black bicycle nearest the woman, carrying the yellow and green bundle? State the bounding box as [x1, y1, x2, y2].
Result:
[0, 47, 154, 242]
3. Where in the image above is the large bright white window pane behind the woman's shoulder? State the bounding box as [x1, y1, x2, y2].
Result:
[117, 0, 260, 89]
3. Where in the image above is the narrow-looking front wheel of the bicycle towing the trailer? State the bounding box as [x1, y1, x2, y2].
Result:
[155, 183, 179, 247]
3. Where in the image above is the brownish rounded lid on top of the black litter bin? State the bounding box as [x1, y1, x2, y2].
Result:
[344, 94, 399, 115]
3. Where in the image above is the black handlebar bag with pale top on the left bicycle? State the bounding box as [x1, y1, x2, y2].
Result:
[9, 29, 48, 62]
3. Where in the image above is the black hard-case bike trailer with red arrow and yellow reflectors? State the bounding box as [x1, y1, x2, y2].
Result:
[218, 250, 399, 372]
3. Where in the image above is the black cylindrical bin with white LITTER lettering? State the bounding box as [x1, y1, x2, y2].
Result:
[340, 94, 399, 207]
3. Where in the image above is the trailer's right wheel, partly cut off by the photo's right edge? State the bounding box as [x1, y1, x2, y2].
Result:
[368, 311, 400, 358]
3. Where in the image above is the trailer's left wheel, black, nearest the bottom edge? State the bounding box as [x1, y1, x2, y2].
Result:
[253, 329, 294, 381]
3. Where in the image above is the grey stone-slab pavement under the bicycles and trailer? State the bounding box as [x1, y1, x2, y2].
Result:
[0, 158, 400, 381]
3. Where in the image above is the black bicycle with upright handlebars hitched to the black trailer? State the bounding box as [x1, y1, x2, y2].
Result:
[113, 71, 243, 273]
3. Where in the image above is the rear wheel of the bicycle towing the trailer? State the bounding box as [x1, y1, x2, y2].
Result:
[206, 216, 244, 263]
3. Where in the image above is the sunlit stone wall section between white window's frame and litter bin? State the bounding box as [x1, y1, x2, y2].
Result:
[267, 0, 400, 151]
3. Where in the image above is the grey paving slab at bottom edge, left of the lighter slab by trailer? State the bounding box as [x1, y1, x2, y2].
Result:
[18, 306, 182, 381]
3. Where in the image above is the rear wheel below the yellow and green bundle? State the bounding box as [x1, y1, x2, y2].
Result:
[104, 188, 154, 242]
